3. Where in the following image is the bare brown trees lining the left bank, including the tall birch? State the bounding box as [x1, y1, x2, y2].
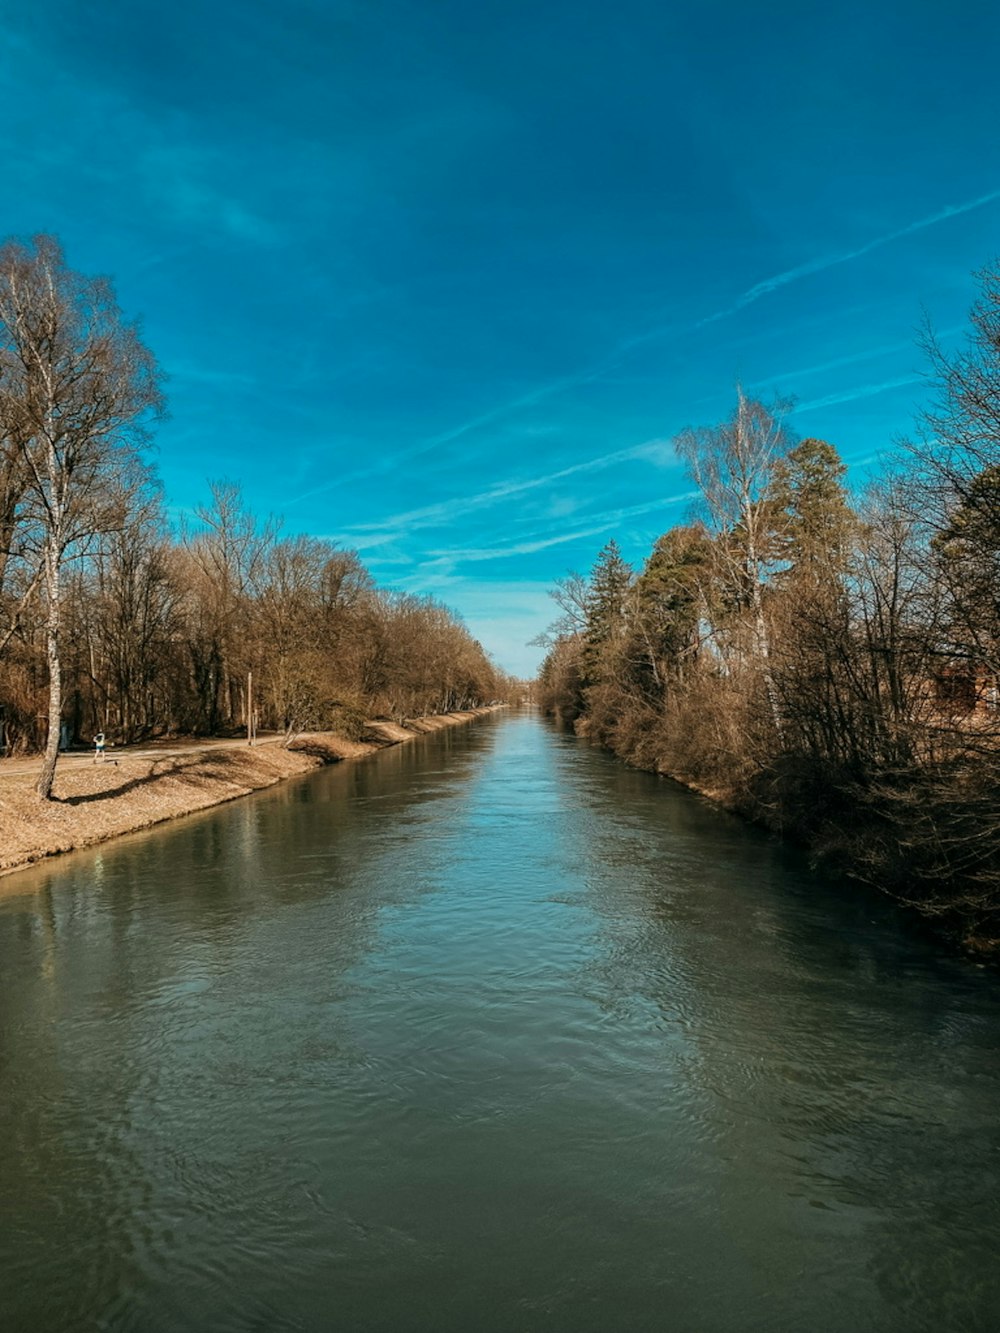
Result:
[0, 236, 513, 797]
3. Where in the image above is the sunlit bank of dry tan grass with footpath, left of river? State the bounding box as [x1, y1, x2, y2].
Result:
[0, 708, 496, 892]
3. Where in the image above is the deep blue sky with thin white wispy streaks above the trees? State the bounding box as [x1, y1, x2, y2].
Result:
[0, 0, 1000, 674]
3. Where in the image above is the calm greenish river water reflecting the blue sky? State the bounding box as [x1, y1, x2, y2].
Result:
[0, 712, 1000, 1333]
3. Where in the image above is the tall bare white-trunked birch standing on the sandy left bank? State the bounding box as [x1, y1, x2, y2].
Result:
[0, 236, 161, 800]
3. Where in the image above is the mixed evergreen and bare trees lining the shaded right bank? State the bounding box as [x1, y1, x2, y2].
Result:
[540, 265, 1000, 946]
